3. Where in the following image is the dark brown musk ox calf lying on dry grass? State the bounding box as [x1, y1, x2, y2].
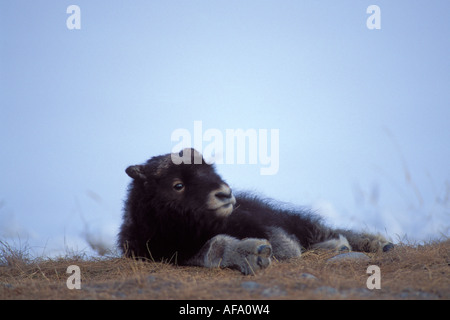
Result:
[118, 149, 393, 274]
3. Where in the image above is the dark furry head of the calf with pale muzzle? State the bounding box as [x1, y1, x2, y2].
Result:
[126, 149, 236, 217]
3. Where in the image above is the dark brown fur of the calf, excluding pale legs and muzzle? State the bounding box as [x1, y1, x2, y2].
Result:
[118, 149, 387, 264]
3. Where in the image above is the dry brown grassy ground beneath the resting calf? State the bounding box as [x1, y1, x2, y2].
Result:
[0, 240, 450, 300]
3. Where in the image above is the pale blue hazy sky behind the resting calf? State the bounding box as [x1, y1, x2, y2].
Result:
[0, 0, 450, 253]
